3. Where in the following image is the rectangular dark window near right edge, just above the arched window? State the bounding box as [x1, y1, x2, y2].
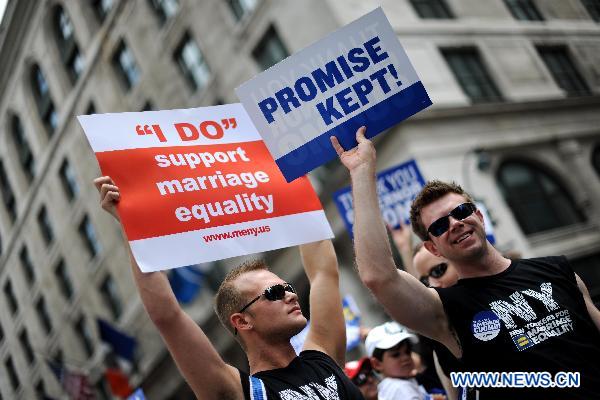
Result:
[537, 47, 591, 96]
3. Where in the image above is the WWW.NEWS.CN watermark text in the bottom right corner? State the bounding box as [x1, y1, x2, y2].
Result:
[450, 371, 581, 388]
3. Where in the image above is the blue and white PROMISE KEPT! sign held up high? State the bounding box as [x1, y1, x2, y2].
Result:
[236, 8, 431, 182]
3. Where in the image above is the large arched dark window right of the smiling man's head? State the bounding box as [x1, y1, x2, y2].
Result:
[497, 161, 585, 235]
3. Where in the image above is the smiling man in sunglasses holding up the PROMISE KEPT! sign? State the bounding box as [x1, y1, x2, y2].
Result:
[331, 127, 600, 400]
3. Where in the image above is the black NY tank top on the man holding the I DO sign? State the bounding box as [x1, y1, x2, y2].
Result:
[240, 350, 364, 400]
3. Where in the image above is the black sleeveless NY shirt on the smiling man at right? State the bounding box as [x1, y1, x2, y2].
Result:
[436, 257, 600, 400]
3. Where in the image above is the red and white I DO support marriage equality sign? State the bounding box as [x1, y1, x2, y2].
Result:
[78, 104, 333, 272]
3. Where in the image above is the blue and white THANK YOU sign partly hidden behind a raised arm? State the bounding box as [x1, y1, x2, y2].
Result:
[333, 160, 425, 236]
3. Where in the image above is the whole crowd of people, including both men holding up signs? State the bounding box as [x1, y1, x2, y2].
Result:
[95, 127, 600, 400]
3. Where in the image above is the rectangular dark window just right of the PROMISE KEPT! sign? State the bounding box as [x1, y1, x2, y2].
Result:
[442, 48, 502, 103]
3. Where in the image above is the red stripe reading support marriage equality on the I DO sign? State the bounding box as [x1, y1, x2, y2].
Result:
[96, 141, 322, 241]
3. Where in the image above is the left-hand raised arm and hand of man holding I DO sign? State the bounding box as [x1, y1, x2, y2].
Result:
[94, 177, 243, 400]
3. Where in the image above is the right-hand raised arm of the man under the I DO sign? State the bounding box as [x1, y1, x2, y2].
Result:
[300, 240, 346, 366]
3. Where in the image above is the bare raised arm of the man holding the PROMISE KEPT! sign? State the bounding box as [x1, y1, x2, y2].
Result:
[331, 127, 460, 356]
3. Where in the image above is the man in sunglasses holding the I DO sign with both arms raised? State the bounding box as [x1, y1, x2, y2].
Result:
[94, 177, 363, 400]
